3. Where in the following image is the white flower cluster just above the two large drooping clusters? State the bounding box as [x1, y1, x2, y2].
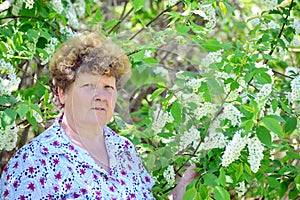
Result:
[220, 104, 243, 126]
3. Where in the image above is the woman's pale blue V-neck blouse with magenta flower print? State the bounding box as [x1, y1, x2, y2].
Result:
[0, 120, 154, 200]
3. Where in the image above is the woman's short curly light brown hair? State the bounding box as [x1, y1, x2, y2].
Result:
[50, 32, 131, 109]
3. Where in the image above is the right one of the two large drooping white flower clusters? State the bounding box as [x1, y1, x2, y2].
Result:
[247, 136, 264, 173]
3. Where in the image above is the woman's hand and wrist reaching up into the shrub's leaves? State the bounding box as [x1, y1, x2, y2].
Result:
[168, 165, 198, 200]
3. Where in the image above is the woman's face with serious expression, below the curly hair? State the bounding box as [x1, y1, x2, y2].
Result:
[60, 73, 117, 130]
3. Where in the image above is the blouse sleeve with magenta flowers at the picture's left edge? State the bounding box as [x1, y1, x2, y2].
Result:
[0, 141, 48, 200]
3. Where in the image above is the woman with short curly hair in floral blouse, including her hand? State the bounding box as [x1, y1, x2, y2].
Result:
[0, 33, 195, 200]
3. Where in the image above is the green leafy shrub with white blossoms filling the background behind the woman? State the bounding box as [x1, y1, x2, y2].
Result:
[0, 0, 300, 200]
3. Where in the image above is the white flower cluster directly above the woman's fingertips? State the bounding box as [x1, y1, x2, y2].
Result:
[179, 126, 200, 150]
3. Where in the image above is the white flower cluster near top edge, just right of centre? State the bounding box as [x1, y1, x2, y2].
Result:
[194, 4, 217, 29]
